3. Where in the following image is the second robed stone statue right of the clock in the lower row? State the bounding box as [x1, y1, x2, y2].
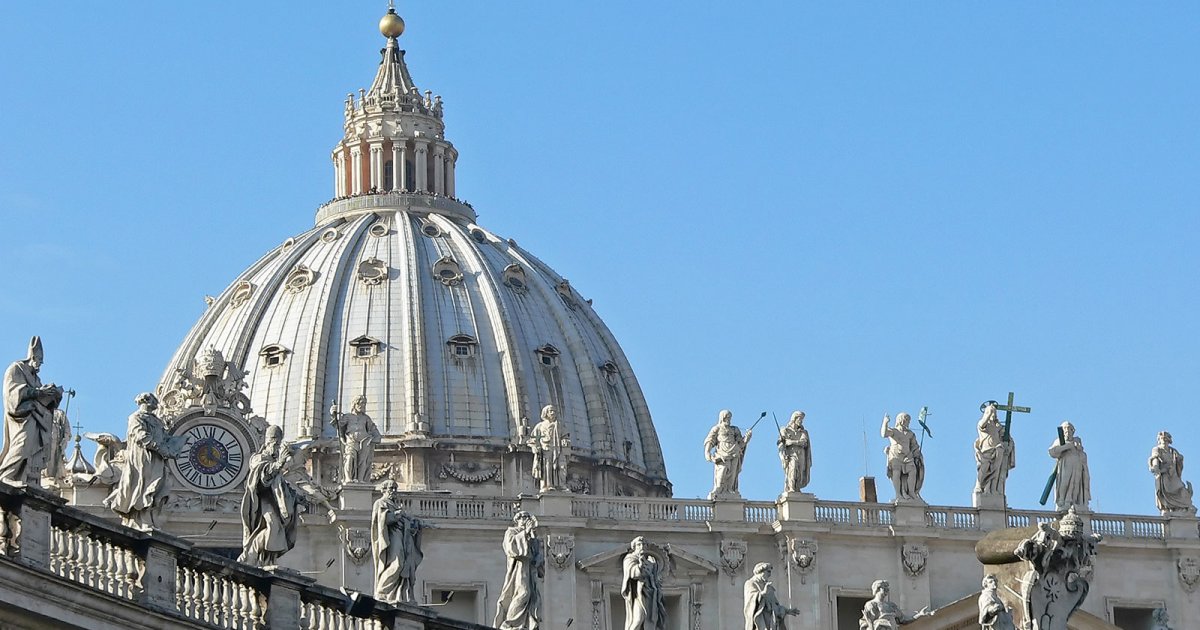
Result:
[371, 479, 428, 602]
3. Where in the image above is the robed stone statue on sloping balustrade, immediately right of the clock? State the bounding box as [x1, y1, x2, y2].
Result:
[238, 425, 301, 566]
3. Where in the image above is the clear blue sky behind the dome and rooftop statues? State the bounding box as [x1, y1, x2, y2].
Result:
[0, 1, 1200, 514]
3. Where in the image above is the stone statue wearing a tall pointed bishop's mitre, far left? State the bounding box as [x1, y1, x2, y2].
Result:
[0, 337, 62, 486]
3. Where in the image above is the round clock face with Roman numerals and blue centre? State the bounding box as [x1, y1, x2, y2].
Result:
[170, 415, 253, 494]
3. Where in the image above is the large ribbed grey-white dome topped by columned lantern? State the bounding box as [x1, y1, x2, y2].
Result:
[158, 13, 671, 496]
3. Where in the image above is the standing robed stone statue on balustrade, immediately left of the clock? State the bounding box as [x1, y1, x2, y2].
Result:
[104, 392, 187, 529]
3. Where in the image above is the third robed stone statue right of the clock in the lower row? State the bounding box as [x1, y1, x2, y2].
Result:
[492, 510, 546, 630]
